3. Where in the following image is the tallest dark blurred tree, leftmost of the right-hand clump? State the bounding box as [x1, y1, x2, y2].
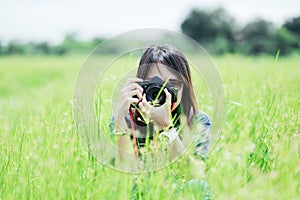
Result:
[181, 8, 236, 53]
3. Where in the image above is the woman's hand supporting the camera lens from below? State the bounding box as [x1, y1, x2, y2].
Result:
[138, 88, 173, 130]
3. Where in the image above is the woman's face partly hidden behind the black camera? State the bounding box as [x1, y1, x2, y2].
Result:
[145, 63, 183, 108]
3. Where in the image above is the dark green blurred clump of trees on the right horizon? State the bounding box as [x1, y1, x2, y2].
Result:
[181, 8, 300, 55]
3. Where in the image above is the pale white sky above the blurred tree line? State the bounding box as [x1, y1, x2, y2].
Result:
[0, 0, 300, 43]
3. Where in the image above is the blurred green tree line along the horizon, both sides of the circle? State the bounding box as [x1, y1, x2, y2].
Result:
[0, 8, 300, 55]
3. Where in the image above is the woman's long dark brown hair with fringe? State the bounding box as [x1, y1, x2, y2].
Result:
[136, 45, 197, 126]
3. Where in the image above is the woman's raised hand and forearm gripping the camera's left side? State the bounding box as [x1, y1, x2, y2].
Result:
[114, 78, 143, 129]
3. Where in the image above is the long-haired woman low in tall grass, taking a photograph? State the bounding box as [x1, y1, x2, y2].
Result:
[110, 45, 211, 179]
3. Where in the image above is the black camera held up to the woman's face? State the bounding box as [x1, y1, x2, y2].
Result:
[132, 76, 178, 107]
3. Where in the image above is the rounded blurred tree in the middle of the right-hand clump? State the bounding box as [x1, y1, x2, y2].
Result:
[238, 19, 277, 55]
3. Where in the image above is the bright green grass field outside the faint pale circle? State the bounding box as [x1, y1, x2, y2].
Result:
[0, 55, 300, 199]
